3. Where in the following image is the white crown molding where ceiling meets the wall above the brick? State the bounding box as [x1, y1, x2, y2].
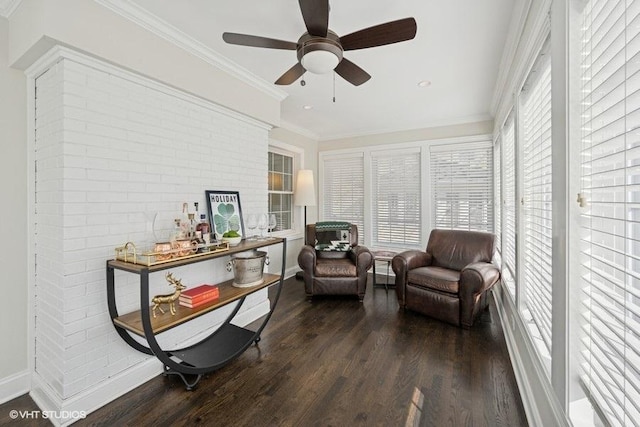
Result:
[95, 0, 289, 101]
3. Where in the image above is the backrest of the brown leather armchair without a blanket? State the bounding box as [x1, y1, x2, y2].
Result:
[427, 229, 495, 271]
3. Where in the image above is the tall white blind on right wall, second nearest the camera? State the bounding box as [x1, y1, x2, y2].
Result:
[520, 44, 552, 357]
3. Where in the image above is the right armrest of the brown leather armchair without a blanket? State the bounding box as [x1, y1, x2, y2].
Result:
[458, 262, 500, 327]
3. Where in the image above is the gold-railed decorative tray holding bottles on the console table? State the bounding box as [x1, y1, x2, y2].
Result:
[116, 242, 229, 267]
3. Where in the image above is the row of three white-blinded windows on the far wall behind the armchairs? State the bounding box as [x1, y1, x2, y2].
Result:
[319, 138, 494, 250]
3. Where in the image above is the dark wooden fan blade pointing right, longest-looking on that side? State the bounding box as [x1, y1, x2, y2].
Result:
[340, 18, 418, 50]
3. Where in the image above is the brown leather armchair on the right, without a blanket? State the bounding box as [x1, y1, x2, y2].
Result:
[391, 229, 500, 328]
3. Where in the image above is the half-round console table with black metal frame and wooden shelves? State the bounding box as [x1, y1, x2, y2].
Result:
[107, 238, 287, 390]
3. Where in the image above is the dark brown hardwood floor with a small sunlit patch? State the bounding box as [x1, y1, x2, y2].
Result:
[0, 278, 527, 427]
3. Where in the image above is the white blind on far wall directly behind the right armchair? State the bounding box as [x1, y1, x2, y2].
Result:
[430, 142, 493, 232]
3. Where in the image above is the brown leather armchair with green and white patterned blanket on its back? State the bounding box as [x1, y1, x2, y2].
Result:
[298, 223, 373, 301]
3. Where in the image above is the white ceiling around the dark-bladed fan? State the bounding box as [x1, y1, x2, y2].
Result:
[6, 0, 519, 140]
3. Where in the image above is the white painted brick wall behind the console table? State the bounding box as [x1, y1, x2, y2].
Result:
[35, 58, 268, 400]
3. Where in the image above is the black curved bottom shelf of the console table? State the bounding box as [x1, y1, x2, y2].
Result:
[167, 323, 255, 371]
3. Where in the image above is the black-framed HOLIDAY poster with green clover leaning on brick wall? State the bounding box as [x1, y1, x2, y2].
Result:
[205, 190, 244, 237]
